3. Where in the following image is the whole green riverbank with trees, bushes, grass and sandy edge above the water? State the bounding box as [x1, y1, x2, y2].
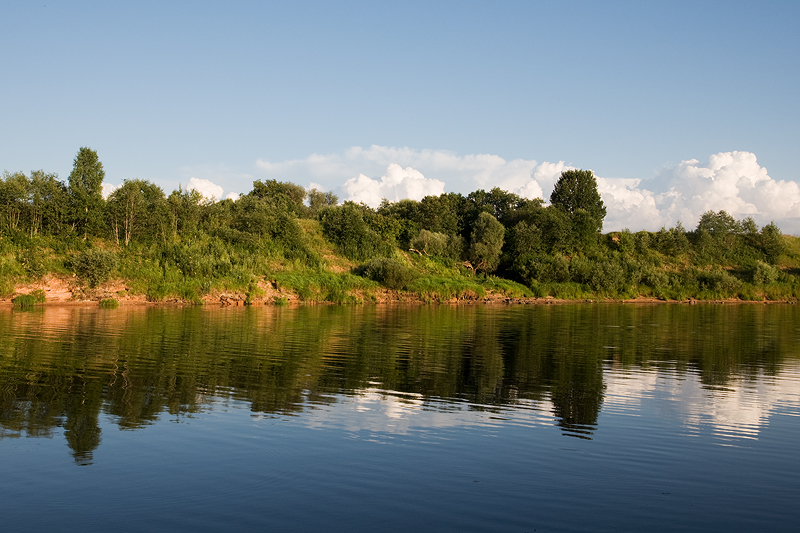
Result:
[0, 148, 800, 305]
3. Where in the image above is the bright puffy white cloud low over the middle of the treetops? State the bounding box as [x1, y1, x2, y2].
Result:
[343, 163, 444, 207]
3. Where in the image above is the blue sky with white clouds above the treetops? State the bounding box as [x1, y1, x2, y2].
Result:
[0, 0, 800, 234]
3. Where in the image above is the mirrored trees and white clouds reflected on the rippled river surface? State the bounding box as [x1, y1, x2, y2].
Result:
[0, 305, 800, 464]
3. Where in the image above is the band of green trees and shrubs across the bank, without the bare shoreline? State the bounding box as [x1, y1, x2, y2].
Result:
[0, 147, 796, 298]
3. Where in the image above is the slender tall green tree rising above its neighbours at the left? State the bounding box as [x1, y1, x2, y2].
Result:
[69, 147, 106, 238]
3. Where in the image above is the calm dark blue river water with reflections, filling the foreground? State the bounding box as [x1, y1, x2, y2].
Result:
[0, 305, 800, 533]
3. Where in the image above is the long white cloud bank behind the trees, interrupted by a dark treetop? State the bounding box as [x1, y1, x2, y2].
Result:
[256, 145, 800, 234]
